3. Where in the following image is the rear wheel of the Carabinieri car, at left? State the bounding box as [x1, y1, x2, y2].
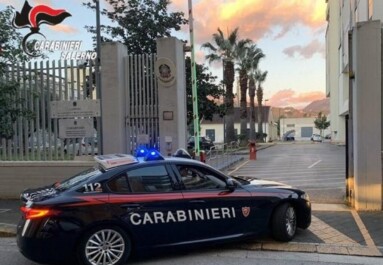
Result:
[78, 226, 132, 265]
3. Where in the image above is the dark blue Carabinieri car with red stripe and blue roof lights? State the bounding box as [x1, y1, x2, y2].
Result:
[17, 150, 311, 265]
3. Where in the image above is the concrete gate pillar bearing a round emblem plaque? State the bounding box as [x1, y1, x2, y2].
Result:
[155, 37, 187, 155]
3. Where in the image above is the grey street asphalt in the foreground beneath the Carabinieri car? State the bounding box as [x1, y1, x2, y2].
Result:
[0, 238, 382, 265]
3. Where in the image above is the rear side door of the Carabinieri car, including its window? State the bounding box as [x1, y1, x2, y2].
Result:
[108, 163, 187, 247]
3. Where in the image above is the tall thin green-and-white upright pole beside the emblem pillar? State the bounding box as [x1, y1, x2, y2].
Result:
[188, 0, 200, 157]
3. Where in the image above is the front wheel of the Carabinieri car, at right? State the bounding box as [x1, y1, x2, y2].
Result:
[271, 203, 297, 242]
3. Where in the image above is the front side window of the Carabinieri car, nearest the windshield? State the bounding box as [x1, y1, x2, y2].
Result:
[177, 165, 226, 190]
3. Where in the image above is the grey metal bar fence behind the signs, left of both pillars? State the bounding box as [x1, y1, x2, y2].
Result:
[0, 61, 100, 161]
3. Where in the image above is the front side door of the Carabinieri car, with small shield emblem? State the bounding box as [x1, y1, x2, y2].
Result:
[173, 163, 256, 241]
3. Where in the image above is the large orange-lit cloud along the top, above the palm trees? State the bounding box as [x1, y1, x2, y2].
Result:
[172, 0, 326, 43]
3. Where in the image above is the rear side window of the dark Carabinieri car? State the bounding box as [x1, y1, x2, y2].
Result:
[108, 165, 173, 193]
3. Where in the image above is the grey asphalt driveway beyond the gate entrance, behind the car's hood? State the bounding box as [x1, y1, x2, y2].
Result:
[229, 142, 346, 203]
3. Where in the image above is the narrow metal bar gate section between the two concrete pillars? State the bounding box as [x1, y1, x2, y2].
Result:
[124, 54, 159, 154]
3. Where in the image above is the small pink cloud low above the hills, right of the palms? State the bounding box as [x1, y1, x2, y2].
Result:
[269, 89, 326, 109]
